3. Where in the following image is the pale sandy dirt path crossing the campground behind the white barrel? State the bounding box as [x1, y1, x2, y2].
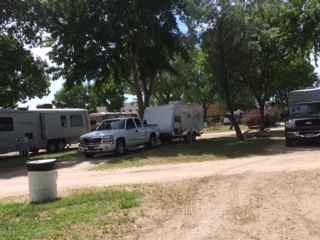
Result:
[0, 132, 320, 240]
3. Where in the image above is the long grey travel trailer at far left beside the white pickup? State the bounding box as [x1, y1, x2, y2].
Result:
[0, 109, 90, 154]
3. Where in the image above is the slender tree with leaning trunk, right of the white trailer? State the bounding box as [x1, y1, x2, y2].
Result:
[201, 1, 252, 139]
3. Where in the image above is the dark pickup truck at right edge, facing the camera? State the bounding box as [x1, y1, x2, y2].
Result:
[285, 101, 320, 147]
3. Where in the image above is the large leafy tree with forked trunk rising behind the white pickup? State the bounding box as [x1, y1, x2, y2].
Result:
[47, 0, 188, 116]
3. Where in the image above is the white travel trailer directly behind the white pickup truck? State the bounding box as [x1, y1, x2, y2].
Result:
[143, 101, 204, 143]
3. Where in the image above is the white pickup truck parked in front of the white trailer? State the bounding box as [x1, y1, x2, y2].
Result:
[79, 117, 159, 158]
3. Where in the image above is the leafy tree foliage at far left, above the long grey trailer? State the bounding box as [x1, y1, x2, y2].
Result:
[0, 0, 50, 108]
